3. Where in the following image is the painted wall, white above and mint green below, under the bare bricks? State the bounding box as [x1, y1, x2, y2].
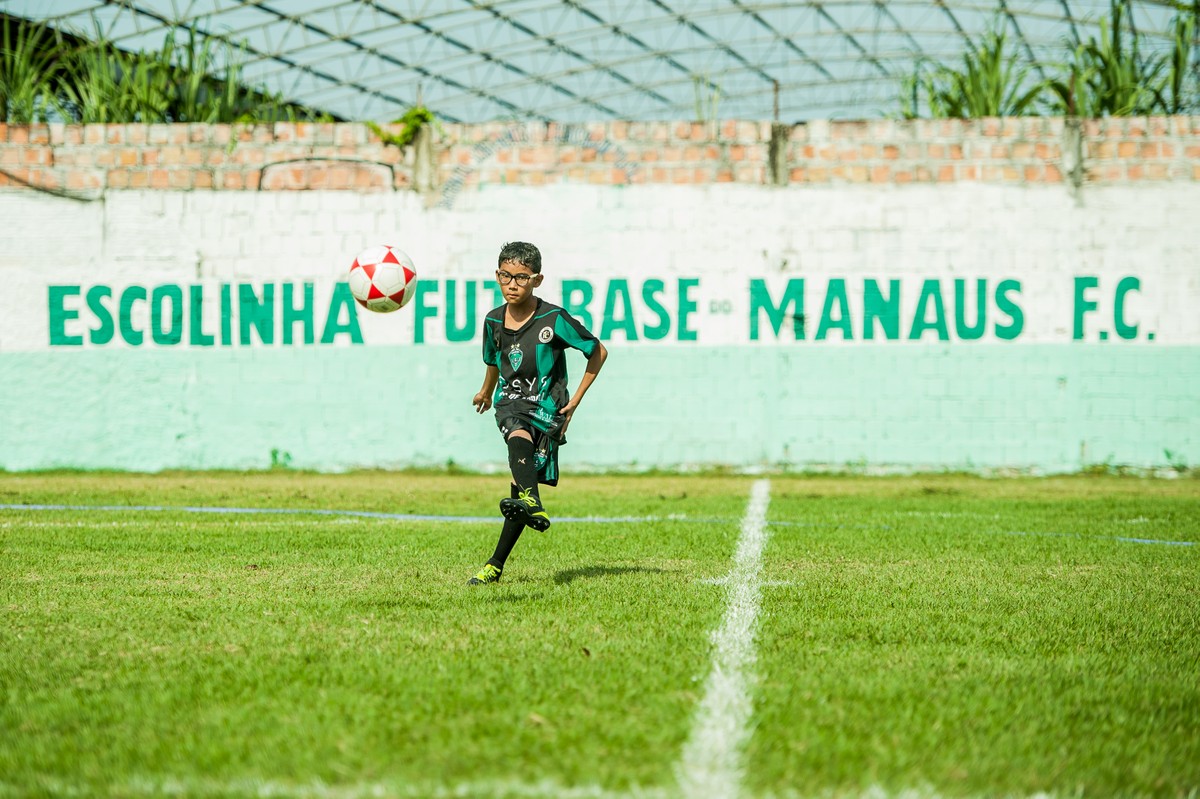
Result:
[0, 182, 1200, 470]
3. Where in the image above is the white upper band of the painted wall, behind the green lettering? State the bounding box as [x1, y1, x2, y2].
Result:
[0, 184, 1200, 352]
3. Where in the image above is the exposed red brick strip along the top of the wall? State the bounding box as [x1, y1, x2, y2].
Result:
[0, 116, 1200, 194]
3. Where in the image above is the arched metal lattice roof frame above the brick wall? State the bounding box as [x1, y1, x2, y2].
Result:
[0, 0, 1190, 122]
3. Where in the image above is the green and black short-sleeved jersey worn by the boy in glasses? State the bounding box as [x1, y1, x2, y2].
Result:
[484, 298, 600, 439]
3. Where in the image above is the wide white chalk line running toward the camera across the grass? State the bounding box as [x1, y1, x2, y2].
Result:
[676, 480, 770, 799]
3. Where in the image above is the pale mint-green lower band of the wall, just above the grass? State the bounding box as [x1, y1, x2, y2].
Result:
[0, 343, 1200, 474]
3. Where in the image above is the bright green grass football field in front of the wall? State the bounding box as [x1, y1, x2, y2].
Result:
[0, 471, 1200, 798]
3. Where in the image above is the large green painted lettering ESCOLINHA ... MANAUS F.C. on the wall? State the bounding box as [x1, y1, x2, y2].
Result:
[47, 275, 1154, 347]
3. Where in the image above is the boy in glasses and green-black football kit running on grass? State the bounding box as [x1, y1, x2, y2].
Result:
[468, 241, 608, 585]
